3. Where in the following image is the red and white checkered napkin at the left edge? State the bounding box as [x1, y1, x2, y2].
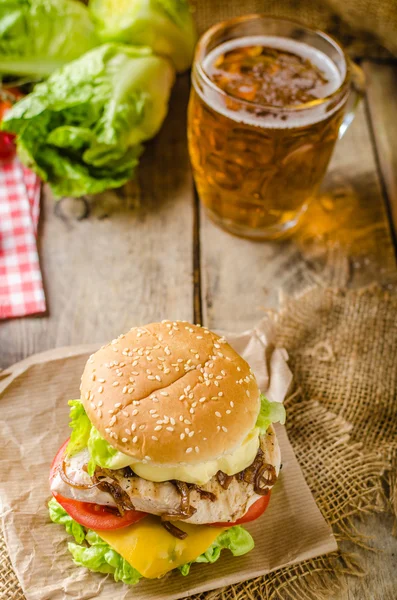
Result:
[0, 157, 46, 319]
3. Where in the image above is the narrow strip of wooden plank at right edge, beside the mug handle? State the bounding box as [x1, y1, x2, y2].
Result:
[364, 62, 397, 236]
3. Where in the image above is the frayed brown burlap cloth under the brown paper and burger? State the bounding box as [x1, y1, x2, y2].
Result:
[0, 287, 397, 600]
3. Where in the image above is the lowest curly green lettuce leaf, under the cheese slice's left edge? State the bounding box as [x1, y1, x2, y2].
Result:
[68, 530, 142, 585]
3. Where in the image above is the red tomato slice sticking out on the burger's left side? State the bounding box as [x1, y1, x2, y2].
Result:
[50, 440, 147, 531]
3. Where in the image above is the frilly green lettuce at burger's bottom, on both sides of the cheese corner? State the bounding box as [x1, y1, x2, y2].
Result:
[48, 498, 255, 585]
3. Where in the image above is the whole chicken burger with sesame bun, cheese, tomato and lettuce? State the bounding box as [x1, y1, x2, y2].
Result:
[49, 321, 285, 584]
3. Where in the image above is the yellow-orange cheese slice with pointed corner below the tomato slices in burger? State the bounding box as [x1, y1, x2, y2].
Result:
[96, 516, 224, 579]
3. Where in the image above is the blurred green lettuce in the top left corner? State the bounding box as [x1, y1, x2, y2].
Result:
[0, 0, 99, 77]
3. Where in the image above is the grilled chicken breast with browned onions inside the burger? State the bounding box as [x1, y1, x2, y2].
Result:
[51, 427, 280, 525]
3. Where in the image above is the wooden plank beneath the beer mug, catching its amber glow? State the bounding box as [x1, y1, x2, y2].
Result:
[201, 100, 397, 330]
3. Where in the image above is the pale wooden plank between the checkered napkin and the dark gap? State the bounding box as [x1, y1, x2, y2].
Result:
[0, 75, 193, 367]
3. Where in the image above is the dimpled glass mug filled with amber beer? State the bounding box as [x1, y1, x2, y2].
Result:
[188, 15, 363, 240]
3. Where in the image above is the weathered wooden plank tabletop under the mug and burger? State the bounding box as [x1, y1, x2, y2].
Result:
[0, 62, 397, 600]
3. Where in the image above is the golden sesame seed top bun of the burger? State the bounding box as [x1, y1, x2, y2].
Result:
[81, 321, 260, 466]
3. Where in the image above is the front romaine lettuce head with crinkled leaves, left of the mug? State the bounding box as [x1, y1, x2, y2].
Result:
[2, 44, 174, 197]
